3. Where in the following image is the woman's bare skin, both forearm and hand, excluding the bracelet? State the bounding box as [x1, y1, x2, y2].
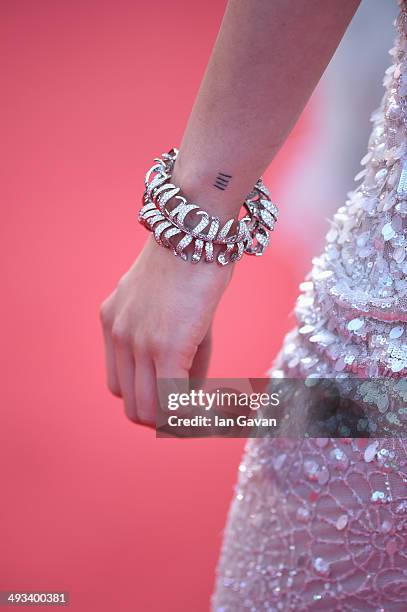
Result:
[100, 0, 359, 426]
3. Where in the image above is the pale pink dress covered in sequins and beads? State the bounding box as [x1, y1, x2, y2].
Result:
[212, 5, 407, 612]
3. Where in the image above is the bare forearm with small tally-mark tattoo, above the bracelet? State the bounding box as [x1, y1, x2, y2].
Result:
[173, 0, 359, 217]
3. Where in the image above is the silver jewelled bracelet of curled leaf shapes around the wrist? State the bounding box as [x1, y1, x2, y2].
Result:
[138, 148, 278, 266]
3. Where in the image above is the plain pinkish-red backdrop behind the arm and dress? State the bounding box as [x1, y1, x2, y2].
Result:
[0, 0, 325, 612]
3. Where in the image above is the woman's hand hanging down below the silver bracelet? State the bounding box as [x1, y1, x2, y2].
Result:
[100, 236, 233, 425]
